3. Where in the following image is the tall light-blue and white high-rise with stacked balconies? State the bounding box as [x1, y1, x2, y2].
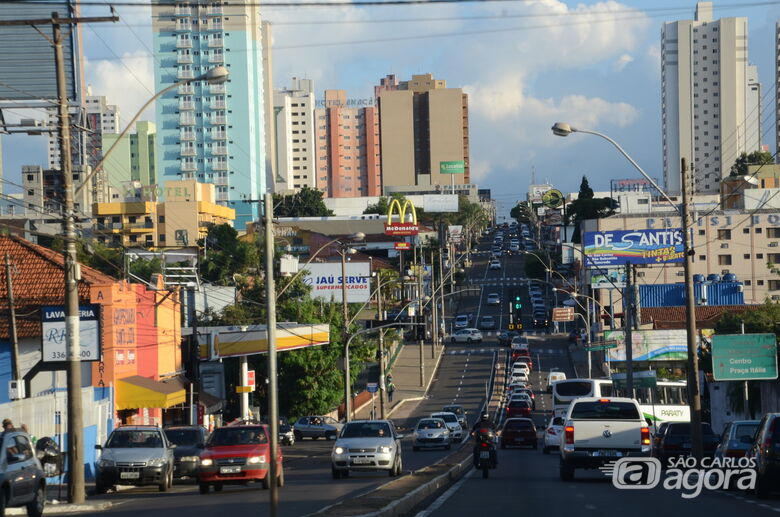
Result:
[152, 0, 270, 225]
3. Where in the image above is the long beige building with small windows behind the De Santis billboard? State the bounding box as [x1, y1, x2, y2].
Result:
[583, 209, 780, 303]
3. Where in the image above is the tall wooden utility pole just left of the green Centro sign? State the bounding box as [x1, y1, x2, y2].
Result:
[680, 158, 704, 460]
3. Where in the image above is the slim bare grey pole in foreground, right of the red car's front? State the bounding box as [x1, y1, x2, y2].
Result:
[264, 192, 282, 517]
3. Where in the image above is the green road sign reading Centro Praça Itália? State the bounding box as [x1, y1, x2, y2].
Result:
[712, 334, 777, 381]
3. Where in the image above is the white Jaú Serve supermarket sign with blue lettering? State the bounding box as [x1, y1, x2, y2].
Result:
[303, 262, 371, 303]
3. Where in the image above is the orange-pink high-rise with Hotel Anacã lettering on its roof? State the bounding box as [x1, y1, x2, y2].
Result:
[314, 90, 382, 197]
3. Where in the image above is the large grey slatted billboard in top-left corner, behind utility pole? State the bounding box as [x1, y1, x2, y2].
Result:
[0, 0, 81, 103]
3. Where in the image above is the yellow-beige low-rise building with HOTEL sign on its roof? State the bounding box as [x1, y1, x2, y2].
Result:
[92, 180, 236, 247]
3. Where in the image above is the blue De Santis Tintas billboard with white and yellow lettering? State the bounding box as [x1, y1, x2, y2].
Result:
[583, 228, 684, 268]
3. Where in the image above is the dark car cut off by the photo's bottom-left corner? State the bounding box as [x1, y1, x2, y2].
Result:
[0, 429, 48, 517]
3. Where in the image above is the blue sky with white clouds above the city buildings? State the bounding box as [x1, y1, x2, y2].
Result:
[3, 0, 780, 218]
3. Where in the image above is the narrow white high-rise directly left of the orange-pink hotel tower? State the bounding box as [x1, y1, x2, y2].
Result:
[274, 77, 317, 193]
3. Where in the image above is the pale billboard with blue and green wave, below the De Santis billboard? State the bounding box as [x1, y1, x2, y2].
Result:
[604, 329, 713, 361]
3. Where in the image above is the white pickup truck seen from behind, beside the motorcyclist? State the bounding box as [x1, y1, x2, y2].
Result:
[560, 397, 652, 481]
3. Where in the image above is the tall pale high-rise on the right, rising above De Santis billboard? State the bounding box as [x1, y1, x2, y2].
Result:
[661, 2, 761, 194]
